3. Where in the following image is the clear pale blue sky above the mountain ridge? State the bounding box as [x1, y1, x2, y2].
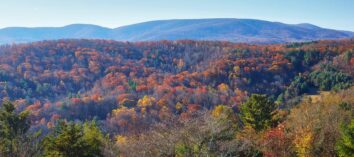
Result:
[0, 0, 354, 31]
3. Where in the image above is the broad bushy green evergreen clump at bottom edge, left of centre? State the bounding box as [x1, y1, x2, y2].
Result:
[44, 121, 104, 157]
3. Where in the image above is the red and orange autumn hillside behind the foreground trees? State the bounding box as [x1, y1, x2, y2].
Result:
[0, 40, 354, 120]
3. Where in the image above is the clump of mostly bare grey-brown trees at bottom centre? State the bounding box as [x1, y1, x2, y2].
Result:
[117, 110, 262, 157]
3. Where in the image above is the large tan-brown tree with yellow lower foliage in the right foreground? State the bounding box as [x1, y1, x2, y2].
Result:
[285, 89, 354, 156]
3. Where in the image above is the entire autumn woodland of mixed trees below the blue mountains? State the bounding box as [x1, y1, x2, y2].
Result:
[0, 39, 354, 157]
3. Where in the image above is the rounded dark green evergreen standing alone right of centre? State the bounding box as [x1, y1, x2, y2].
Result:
[240, 94, 277, 131]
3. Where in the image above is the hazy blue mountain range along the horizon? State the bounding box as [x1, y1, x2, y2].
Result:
[0, 19, 354, 44]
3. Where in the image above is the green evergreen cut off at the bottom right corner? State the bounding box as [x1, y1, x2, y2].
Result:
[336, 119, 354, 157]
